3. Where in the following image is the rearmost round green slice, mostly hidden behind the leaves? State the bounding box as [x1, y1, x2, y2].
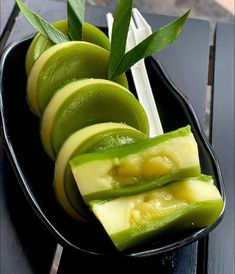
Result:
[25, 20, 110, 76]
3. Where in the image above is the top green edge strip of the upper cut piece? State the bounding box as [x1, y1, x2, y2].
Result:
[70, 125, 191, 167]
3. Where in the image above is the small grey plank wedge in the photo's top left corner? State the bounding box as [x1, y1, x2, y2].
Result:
[0, 0, 15, 37]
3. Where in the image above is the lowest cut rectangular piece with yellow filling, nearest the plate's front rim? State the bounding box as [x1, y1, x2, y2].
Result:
[90, 176, 223, 251]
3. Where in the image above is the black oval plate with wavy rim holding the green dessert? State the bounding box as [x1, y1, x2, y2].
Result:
[0, 38, 225, 256]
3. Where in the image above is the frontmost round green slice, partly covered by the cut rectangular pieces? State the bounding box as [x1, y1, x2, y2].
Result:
[54, 122, 147, 221]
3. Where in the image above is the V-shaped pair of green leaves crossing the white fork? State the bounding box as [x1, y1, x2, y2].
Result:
[108, 0, 190, 80]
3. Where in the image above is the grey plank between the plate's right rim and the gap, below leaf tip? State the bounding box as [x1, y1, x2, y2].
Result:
[152, 16, 210, 132]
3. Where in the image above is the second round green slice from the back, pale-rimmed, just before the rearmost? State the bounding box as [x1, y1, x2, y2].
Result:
[27, 41, 128, 117]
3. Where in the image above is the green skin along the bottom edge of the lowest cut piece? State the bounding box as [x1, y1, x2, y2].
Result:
[90, 175, 224, 251]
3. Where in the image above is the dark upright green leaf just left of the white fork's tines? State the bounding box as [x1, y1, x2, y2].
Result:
[108, 0, 133, 79]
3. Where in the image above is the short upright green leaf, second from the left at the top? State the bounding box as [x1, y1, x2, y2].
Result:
[67, 0, 85, 40]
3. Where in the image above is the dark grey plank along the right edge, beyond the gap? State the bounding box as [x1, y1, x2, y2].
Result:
[208, 23, 235, 274]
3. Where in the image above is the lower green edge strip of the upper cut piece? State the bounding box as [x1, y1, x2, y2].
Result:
[83, 166, 201, 203]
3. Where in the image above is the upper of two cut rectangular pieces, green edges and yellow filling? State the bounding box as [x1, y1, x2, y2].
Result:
[70, 126, 200, 203]
